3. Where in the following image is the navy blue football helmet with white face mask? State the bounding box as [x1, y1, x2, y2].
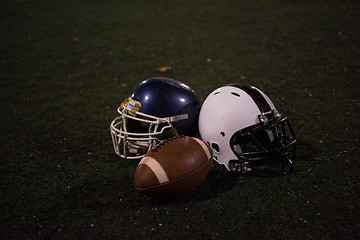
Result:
[110, 77, 200, 159]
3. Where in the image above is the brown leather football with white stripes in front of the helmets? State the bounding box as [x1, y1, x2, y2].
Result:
[134, 136, 213, 198]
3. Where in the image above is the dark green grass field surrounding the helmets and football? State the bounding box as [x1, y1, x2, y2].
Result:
[0, 0, 360, 239]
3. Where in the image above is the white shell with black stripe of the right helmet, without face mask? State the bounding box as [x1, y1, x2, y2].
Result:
[199, 83, 275, 170]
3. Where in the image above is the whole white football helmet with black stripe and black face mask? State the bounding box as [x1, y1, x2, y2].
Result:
[199, 83, 296, 175]
